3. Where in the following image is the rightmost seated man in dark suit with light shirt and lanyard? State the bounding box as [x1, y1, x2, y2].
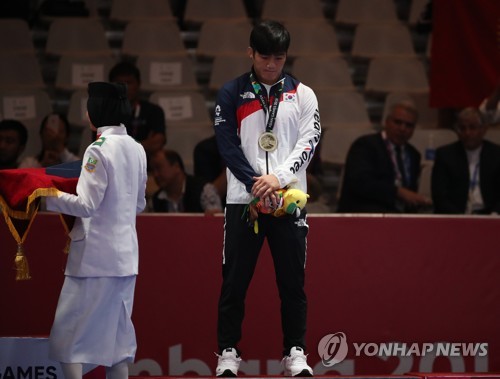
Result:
[431, 108, 500, 214]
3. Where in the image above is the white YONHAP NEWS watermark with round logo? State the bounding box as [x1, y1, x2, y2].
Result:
[318, 332, 488, 367]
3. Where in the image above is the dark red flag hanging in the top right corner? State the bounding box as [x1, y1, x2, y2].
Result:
[430, 0, 500, 108]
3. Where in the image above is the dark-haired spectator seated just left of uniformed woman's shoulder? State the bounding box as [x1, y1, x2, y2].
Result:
[19, 113, 80, 168]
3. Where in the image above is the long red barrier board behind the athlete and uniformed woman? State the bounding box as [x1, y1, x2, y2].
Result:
[0, 213, 500, 376]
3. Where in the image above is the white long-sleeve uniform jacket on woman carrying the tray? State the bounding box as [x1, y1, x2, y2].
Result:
[47, 126, 147, 277]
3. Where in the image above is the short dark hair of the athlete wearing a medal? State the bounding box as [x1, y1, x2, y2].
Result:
[250, 20, 290, 55]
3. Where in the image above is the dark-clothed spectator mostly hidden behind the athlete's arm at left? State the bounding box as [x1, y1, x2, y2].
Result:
[194, 135, 227, 204]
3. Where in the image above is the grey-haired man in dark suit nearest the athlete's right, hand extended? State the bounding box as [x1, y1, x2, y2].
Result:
[338, 102, 430, 213]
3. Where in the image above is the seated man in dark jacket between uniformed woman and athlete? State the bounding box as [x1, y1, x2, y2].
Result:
[150, 150, 222, 214]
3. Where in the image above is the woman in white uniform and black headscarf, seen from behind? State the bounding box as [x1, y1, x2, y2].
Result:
[47, 82, 147, 379]
